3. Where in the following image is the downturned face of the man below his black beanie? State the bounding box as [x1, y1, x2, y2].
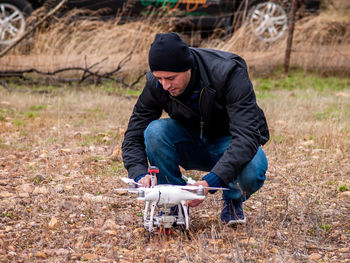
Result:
[152, 69, 191, 97]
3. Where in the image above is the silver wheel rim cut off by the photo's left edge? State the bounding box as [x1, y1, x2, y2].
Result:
[0, 4, 25, 45]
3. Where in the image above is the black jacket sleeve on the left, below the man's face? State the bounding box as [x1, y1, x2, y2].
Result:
[122, 75, 162, 179]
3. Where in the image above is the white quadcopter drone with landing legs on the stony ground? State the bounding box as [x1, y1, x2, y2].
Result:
[116, 166, 228, 233]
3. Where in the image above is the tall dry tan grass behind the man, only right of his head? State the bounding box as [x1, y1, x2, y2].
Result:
[205, 9, 350, 75]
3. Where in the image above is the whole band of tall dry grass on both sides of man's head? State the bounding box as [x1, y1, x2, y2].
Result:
[0, 0, 350, 78]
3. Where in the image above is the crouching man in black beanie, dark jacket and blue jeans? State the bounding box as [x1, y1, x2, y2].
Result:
[122, 33, 269, 225]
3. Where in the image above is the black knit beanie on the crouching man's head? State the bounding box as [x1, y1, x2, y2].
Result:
[148, 33, 193, 72]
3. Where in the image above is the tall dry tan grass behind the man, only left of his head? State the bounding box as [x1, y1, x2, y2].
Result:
[1, 13, 162, 75]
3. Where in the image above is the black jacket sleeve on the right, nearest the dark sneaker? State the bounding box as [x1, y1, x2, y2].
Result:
[212, 69, 260, 184]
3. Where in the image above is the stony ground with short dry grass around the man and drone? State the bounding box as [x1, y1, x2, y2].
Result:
[0, 80, 350, 263]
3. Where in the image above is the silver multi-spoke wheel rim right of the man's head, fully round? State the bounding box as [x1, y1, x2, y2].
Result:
[250, 2, 288, 42]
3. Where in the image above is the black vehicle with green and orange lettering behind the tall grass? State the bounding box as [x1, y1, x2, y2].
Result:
[0, 0, 320, 45]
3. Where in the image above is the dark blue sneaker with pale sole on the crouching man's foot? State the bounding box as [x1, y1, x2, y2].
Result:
[221, 199, 246, 226]
